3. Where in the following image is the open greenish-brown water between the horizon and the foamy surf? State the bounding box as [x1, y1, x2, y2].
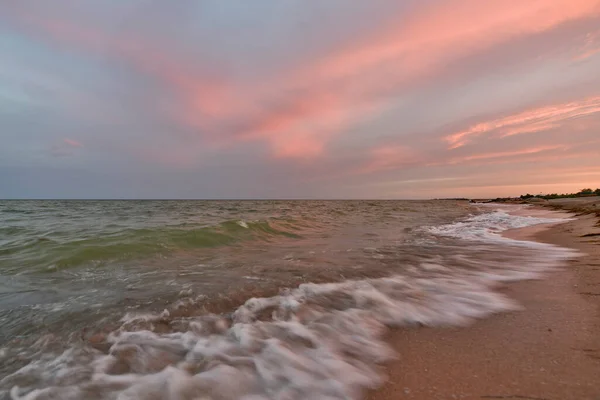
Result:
[0, 201, 470, 341]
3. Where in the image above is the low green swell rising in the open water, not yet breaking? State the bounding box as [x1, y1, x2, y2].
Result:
[0, 219, 302, 271]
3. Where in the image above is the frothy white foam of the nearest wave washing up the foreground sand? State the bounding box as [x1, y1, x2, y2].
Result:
[3, 276, 516, 400]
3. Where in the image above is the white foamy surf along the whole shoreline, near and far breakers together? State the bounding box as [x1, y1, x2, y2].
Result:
[0, 205, 576, 400]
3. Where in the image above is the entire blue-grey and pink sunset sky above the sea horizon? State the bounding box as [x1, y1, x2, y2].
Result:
[0, 0, 600, 199]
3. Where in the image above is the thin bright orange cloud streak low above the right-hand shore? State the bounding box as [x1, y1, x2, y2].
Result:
[444, 97, 600, 149]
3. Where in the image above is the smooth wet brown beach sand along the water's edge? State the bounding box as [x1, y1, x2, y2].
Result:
[368, 206, 600, 400]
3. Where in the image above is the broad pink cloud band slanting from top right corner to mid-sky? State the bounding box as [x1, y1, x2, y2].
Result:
[183, 0, 600, 159]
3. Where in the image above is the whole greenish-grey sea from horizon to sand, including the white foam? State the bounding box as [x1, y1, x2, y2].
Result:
[0, 200, 577, 400]
